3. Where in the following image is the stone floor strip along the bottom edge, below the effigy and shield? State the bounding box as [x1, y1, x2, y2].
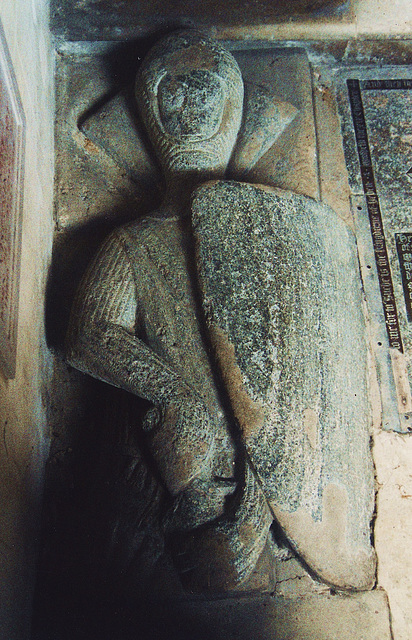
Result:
[33, 590, 392, 640]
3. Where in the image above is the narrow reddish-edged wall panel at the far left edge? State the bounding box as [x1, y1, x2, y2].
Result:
[0, 24, 24, 378]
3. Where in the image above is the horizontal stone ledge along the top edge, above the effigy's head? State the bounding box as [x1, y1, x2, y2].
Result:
[51, 0, 412, 43]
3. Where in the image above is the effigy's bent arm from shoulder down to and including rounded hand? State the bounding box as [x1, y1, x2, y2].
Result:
[66, 232, 214, 495]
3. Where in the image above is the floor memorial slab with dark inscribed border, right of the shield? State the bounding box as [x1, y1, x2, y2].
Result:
[347, 77, 412, 433]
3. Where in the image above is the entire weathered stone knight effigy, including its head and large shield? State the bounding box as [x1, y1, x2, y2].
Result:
[67, 31, 375, 591]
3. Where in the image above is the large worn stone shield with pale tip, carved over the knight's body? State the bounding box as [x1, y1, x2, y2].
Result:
[192, 181, 375, 589]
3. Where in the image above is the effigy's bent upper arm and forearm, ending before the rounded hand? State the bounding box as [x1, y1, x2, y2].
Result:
[66, 233, 196, 405]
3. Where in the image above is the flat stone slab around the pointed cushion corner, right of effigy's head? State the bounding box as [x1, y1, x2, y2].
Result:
[232, 49, 319, 198]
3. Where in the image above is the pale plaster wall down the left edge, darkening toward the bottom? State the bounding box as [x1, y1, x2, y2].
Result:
[0, 0, 54, 640]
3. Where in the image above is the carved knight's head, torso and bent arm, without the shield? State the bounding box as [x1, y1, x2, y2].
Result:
[66, 32, 272, 591]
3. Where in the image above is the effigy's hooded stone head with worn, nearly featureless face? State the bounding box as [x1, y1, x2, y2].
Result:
[135, 30, 243, 175]
